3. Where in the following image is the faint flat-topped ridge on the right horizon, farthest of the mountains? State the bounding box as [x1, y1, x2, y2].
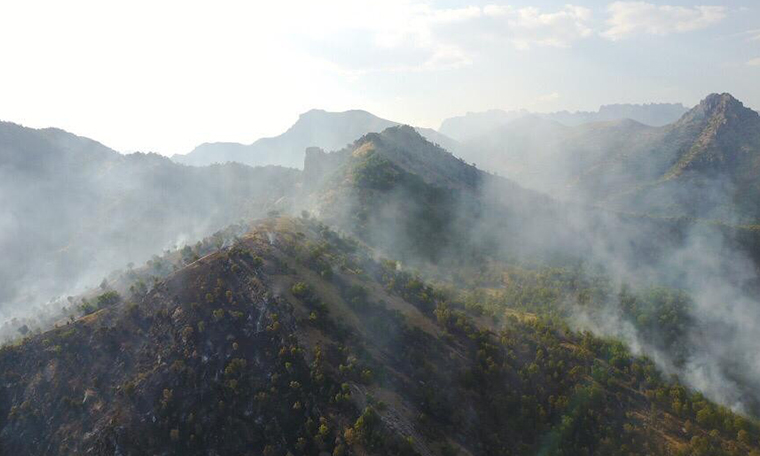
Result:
[439, 103, 688, 141]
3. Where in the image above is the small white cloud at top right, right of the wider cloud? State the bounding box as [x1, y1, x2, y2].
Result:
[602, 2, 726, 40]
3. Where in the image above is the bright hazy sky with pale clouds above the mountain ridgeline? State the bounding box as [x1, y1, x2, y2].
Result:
[0, 0, 760, 155]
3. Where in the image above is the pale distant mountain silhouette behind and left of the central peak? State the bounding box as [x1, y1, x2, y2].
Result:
[172, 109, 456, 168]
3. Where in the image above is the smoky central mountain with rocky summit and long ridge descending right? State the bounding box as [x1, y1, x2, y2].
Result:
[300, 121, 756, 268]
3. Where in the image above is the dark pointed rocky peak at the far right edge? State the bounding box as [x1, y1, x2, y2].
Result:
[577, 94, 760, 223]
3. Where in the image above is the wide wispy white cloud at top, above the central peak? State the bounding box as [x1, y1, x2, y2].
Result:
[308, 1, 593, 73]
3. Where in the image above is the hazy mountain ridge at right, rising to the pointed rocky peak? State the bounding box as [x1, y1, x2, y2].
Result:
[460, 94, 760, 223]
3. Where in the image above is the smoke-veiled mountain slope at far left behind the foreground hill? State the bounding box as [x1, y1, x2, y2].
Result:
[0, 122, 298, 320]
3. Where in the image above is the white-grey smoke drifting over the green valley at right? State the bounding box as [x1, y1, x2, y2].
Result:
[470, 128, 760, 415]
